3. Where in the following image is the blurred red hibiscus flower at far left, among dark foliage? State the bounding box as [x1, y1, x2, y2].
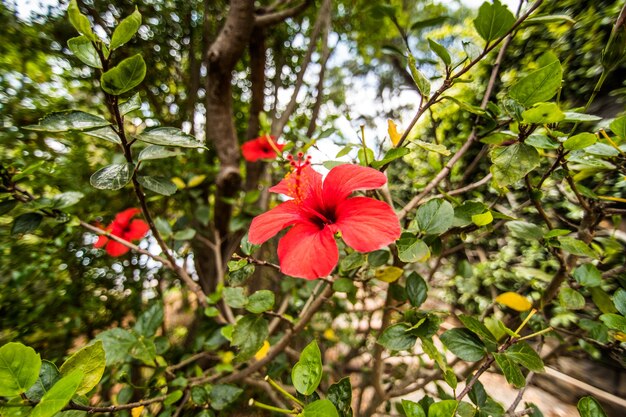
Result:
[93, 208, 150, 256]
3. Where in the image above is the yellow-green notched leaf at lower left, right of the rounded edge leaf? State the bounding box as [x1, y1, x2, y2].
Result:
[59, 340, 106, 395]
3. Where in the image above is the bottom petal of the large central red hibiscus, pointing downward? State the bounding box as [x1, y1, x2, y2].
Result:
[278, 222, 339, 279]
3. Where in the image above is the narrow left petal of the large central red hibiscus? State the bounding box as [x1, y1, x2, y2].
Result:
[248, 201, 304, 245]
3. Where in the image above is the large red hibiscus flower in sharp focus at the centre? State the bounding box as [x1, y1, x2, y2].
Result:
[248, 153, 401, 279]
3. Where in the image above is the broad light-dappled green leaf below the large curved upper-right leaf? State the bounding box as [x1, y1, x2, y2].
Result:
[490, 143, 541, 188]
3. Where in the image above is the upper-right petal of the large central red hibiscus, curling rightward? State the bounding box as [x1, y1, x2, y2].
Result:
[323, 164, 387, 208]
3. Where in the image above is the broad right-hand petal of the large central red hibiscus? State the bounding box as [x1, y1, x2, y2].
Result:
[335, 197, 401, 252]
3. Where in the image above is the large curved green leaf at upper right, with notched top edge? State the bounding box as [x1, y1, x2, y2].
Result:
[509, 52, 563, 107]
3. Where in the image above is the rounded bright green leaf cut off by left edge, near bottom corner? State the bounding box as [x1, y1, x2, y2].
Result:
[0, 342, 41, 397]
